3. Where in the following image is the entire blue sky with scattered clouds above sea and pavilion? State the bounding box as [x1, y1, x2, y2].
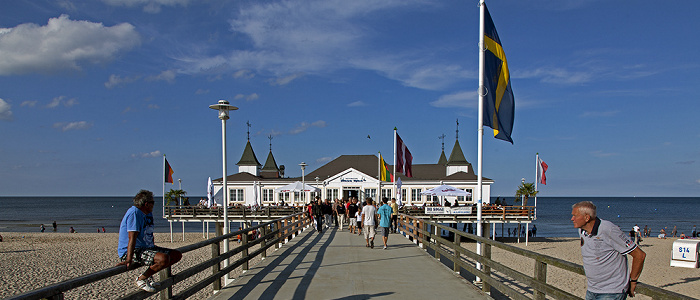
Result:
[0, 0, 700, 197]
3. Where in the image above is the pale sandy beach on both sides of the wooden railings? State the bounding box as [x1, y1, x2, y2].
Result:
[0, 233, 700, 299]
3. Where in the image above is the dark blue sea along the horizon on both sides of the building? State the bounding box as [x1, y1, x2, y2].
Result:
[0, 196, 700, 237]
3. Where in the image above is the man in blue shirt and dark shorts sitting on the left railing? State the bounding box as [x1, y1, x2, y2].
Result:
[117, 190, 182, 293]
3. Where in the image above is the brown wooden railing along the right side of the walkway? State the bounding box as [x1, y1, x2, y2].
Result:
[399, 214, 695, 300]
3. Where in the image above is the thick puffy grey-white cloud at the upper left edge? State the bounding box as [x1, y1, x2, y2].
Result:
[0, 15, 140, 75]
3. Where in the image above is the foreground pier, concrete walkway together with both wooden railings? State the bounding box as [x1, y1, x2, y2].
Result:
[7, 212, 693, 300]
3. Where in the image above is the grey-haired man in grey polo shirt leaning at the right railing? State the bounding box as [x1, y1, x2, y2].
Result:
[571, 201, 646, 300]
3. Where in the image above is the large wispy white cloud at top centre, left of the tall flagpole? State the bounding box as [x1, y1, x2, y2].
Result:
[180, 0, 460, 89]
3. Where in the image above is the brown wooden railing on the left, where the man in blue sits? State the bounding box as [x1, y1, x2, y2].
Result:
[6, 213, 310, 300]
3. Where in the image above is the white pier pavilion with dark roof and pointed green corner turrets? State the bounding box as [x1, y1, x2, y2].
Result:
[213, 140, 494, 206]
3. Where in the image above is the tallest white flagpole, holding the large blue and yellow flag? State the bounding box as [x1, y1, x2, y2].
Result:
[476, 0, 486, 282]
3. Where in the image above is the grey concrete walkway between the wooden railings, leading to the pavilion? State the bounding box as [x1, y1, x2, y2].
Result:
[210, 228, 491, 300]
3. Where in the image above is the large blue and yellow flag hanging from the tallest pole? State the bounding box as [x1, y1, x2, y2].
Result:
[483, 4, 515, 144]
